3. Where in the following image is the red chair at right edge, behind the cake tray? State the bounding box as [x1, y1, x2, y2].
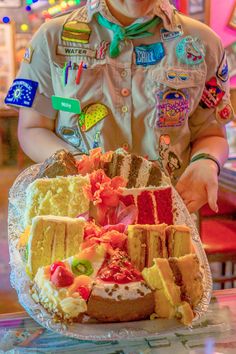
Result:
[199, 201, 236, 288]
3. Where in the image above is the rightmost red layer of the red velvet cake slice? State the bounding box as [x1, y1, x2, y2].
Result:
[154, 187, 173, 225]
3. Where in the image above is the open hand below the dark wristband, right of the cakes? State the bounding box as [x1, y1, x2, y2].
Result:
[176, 159, 218, 213]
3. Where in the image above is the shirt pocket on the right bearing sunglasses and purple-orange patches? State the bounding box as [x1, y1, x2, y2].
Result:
[152, 67, 206, 128]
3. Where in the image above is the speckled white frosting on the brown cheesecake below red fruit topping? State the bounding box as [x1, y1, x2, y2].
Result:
[92, 281, 151, 301]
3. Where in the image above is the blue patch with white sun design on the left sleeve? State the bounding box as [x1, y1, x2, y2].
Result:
[5, 79, 38, 107]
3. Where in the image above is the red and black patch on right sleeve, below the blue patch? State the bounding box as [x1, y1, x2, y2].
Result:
[199, 77, 225, 108]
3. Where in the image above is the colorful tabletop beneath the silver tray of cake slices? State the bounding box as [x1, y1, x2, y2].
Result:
[0, 289, 236, 354]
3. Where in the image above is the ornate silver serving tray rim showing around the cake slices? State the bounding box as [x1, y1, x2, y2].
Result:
[8, 164, 212, 341]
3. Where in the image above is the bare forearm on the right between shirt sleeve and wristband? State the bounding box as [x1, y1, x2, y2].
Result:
[191, 136, 229, 166]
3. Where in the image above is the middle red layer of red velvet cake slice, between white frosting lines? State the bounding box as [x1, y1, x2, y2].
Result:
[137, 191, 155, 225]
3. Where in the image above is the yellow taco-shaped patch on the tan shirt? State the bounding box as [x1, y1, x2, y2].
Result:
[78, 103, 109, 132]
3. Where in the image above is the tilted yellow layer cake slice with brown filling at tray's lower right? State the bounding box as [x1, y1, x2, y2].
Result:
[142, 254, 203, 325]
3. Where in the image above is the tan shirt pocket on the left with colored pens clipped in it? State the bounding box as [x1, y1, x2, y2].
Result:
[52, 57, 103, 103]
